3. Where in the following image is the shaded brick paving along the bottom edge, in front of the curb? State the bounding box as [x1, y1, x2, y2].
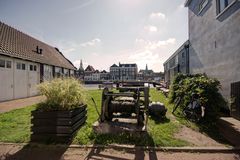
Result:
[0, 145, 240, 160]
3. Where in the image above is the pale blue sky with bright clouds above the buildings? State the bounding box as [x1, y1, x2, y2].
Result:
[0, 0, 188, 72]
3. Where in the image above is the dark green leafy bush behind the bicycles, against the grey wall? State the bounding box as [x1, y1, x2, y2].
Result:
[169, 74, 227, 119]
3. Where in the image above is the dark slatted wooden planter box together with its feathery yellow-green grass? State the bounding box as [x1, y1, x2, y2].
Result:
[31, 78, 87, 142]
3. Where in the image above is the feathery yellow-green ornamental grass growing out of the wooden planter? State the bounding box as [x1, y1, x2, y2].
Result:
[38, 78, 86, 111]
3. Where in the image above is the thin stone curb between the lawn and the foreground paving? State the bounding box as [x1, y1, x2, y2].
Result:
[0, 142, 240, 153]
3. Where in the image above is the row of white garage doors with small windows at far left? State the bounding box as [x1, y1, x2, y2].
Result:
[0, 56, 40, 101]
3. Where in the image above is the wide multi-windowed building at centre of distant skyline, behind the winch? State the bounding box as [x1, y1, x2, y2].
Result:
[110, 63, 138, 81]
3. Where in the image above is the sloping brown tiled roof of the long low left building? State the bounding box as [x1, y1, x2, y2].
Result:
[0, 21, 76, 70]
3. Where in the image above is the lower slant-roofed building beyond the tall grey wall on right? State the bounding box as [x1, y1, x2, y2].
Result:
[163, 41, 189, 84]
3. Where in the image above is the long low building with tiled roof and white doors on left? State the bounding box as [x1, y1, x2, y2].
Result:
[0, 22, 76, 101]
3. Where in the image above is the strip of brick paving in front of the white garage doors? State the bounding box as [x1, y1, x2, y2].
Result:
[0, 96, 44, 113]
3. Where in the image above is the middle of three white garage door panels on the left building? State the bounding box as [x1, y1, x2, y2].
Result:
[14, 60, 28, 99]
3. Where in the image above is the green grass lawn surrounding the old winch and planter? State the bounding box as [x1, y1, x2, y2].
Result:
[0, 89, 221, 146]
